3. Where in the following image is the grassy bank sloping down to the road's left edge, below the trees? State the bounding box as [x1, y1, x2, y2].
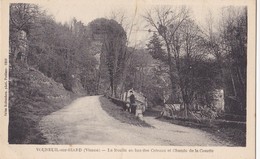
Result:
[8, 66, 74, 144]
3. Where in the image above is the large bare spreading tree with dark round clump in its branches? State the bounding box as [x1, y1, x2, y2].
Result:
[144, 7, 223, 117]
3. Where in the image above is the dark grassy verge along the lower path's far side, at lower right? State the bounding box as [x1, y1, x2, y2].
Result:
[145, 110, 246, 147]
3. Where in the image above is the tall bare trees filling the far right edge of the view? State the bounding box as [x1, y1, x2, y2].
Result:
[205, 7, 247, 114]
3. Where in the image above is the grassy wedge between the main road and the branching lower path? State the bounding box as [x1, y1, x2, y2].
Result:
[99, 97, 152, 127]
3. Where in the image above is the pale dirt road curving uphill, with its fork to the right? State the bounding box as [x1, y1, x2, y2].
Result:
[40, 96, 232, 146]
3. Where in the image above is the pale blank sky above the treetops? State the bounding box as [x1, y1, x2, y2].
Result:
[36, 0, 246, 46]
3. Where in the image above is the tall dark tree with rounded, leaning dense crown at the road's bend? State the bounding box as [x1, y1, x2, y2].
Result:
[89, 18, 127, 97]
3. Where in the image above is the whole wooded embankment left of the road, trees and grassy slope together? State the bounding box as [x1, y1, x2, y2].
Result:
[9, 3, 101, 144]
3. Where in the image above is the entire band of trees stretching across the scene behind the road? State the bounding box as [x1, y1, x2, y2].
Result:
[9, 3, 247, 130]
